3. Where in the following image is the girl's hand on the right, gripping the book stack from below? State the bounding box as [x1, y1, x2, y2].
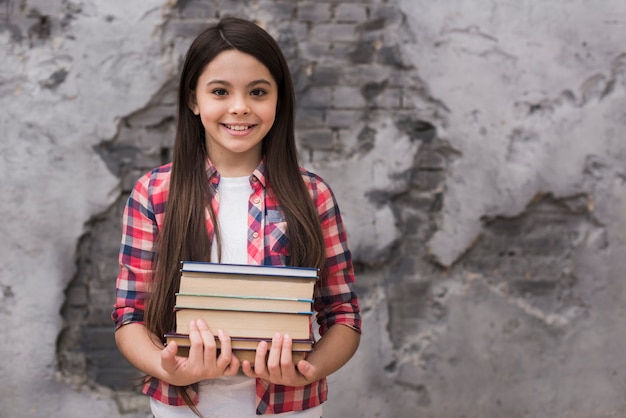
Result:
[241, 334, 319, 386]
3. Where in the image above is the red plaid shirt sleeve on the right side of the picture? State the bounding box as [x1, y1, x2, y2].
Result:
[313, 178, 361, 335]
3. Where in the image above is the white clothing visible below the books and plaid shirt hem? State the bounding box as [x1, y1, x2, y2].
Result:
[150, 376, 322, 418]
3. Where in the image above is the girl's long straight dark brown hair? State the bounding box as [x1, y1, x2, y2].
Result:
[145, 17, 326, 404]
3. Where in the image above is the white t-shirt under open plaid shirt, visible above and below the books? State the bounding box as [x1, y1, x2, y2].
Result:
[150, 176, 322, 418]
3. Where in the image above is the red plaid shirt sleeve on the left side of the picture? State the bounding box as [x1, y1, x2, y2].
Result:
[111, 174, 158, 329]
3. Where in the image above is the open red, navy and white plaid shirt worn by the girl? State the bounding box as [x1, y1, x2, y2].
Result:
[112, 161, 361, 415]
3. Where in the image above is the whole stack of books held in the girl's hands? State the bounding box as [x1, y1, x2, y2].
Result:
[165, 261, 318, 363]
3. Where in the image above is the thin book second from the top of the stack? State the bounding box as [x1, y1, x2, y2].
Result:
[176, 293, 313, 312]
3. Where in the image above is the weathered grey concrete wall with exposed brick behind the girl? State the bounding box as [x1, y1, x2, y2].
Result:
[0, 0, 626, 418]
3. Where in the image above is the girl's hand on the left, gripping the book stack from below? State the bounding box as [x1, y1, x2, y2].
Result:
[161, 320, 240, 386]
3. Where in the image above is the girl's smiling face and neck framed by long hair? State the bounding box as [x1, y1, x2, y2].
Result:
[189, 50, 278, 177]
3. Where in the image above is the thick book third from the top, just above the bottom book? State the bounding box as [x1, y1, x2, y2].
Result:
[175, 308, 313, 339]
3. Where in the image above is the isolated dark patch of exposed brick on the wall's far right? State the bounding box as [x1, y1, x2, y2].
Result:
[461, 195, 596, 311]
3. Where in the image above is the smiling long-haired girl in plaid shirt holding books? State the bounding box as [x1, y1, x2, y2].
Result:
[112, 18, 361, 418]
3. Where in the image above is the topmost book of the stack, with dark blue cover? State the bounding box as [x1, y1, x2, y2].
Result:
[179, 261, 318, 299]
